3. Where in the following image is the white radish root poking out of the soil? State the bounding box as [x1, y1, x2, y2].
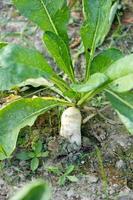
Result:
[60, 107, 82, 148]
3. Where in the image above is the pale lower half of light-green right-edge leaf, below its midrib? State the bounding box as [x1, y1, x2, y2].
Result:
[109, 73, 133, 93]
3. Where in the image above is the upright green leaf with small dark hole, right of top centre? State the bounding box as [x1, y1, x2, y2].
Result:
[81, 0, 117, 80]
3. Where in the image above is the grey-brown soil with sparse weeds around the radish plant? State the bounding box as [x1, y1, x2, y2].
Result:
[0, 0, 133, 200]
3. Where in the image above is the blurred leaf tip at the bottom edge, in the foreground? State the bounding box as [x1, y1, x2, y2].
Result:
[10, 180, 51, 200]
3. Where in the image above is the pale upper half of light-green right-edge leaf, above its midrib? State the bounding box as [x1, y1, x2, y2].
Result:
[105, 54, 133, 80]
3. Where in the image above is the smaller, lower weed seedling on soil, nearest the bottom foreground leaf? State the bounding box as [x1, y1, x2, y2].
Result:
[48, 165, 78, 186]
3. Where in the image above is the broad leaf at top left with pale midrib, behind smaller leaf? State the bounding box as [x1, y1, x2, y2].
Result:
[13, 0, 69, 43]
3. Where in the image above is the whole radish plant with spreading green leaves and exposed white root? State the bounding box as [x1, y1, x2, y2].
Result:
[0, 0, 133, 160]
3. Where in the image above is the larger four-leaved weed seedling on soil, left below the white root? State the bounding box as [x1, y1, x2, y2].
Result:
[16, 141, 48, 171]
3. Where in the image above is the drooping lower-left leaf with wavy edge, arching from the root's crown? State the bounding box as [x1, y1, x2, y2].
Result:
[0, 98, 71, 160]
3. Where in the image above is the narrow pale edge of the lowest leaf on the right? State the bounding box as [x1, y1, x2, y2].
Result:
[117, 112, 133, 135]
